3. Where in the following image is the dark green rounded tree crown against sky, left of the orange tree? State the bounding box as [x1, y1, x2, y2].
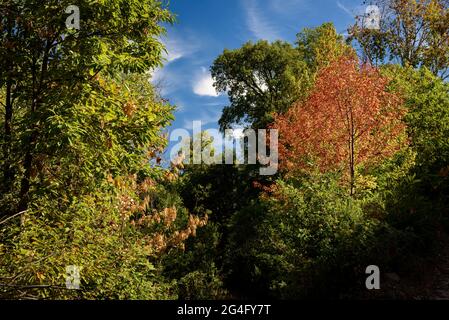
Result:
[211, 41, 311, 130]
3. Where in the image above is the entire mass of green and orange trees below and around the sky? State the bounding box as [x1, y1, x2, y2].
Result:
[0, 0, 449, 299]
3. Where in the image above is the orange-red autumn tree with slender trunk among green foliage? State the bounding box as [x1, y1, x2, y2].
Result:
[272, 57, 406, 188]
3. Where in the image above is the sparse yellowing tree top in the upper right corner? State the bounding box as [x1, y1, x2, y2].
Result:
[349, 0, 449, 79]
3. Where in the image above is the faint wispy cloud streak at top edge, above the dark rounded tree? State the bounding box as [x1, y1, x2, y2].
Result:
[243, 0, 280, 41]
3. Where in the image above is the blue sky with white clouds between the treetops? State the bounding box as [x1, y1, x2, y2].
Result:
[153, 0, 364, 139]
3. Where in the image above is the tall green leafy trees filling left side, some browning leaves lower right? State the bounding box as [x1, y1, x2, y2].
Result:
[0, 0, 207, 299]
